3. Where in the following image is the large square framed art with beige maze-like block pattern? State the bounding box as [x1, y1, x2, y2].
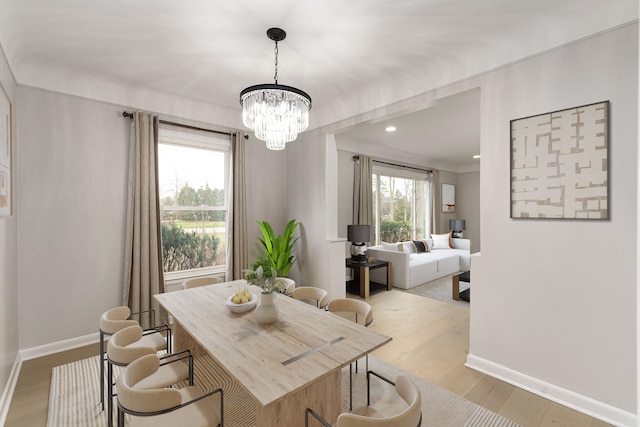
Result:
[511, 101, 609, 220]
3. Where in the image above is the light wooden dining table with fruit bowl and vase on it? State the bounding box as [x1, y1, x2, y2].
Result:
[155, 280, 391, 427]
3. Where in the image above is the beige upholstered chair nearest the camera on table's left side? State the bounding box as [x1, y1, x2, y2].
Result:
[116, 354, 224, 427]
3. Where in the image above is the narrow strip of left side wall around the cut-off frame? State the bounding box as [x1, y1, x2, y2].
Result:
[0, 46, 19, 424]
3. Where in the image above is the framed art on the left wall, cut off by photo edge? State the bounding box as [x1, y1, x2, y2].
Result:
[0, 84, 13, 217]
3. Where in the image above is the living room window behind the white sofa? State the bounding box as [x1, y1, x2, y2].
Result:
[372, 163, 431, 244]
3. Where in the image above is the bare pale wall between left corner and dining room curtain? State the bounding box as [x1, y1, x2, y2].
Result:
[17, 87, 131, 349]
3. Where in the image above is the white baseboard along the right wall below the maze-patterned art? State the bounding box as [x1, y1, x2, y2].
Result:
[465, 354, 638, 427]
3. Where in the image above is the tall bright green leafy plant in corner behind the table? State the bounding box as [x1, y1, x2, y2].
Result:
[254, 219, 300, 277]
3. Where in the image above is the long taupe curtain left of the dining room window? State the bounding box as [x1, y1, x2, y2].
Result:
[122, 112, 166, 328]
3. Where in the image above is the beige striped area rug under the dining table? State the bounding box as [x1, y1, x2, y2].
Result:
[47, 355, 518, 427]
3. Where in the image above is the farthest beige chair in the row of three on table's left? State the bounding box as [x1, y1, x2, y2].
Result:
[100, 306, 171, 410]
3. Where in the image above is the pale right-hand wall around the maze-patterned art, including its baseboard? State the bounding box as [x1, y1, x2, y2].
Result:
[469, 23, 638, 425]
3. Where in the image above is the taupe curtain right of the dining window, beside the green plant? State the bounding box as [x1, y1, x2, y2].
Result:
[226, 132, 249, 280]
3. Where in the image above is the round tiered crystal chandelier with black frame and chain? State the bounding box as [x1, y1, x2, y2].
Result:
[240, 28, 311, 150]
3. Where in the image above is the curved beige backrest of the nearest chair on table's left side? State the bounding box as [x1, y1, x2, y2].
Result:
[116, 354, 182, 413]
